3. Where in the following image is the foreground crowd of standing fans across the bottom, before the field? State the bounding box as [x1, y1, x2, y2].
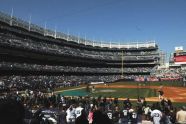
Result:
[0, 90, 186, 124]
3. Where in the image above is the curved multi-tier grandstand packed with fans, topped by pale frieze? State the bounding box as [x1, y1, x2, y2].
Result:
[0, 13, 160, 89]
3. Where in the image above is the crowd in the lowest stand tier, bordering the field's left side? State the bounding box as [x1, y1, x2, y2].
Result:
[0, 75, 120, 91]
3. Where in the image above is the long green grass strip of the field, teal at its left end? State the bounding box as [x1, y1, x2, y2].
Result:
[60, 88, 157, 98]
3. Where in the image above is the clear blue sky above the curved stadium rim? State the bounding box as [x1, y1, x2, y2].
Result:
[0, 0, 186, 53]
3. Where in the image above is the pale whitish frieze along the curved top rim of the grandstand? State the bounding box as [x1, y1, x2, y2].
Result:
[0, 12, 157, 49]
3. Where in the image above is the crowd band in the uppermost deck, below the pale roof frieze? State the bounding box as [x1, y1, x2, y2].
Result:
[0, 33, 159, 61]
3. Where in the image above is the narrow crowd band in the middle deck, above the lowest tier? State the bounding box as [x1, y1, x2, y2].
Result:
[0, 62, 152, 74]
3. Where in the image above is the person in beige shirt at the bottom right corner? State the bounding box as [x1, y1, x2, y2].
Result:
[176, 106, 186, 124]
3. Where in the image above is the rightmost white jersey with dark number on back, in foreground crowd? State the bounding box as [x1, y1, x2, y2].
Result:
[151, 109, 162, 124]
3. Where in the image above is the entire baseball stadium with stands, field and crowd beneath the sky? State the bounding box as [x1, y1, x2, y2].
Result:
[0, 7, 186, 124]
